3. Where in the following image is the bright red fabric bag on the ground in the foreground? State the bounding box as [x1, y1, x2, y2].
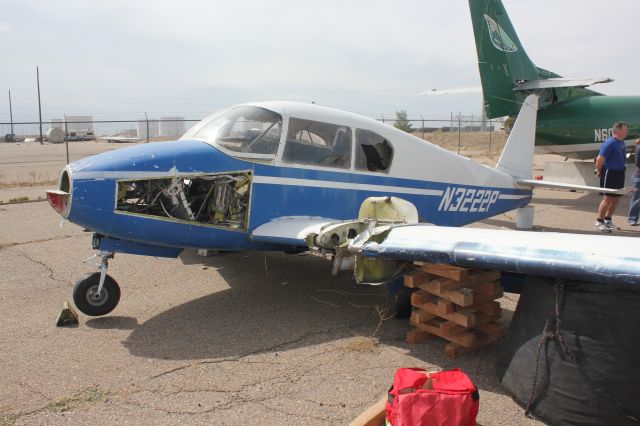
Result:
[386, 368, 480, 426]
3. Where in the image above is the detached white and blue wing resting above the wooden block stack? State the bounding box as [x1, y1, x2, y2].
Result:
[349, 224, 640, 284]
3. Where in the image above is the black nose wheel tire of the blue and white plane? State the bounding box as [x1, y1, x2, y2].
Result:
[73, 272, 120, 317]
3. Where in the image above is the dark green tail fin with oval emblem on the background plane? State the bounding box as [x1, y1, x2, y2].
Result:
[469, 0, 553, 118]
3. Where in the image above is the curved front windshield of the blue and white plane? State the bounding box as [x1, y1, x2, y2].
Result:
[193, 106, 282, 156]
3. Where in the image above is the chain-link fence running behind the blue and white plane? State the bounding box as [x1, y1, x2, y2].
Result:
[0, 114, 506, 189]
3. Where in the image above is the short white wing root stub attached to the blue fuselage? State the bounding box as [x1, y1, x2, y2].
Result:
[251, 216, 340, 247]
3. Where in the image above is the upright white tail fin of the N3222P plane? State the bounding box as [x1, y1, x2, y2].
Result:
[496, 95, 538, 179]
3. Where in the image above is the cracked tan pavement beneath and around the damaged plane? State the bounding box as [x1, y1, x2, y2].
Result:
[0, 191, 637, 425]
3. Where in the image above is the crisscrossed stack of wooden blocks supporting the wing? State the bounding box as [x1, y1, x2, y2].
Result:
[404, 262, 504, 358]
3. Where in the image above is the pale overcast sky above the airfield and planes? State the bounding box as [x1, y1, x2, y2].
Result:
[0, 0, 640, 121]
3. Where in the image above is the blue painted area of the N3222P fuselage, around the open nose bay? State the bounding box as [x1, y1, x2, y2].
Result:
[69, 140, 531, 249]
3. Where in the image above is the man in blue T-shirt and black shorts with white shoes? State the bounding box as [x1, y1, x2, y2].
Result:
[593, 122, 629, 232]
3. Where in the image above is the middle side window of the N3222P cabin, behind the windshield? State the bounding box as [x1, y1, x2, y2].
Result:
[282, 118, 351, 169]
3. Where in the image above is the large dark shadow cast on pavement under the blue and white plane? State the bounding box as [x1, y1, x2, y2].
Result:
[124, 251, 510, 400]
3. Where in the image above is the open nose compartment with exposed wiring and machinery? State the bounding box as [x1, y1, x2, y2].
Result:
[116, 172, 251, 229]
